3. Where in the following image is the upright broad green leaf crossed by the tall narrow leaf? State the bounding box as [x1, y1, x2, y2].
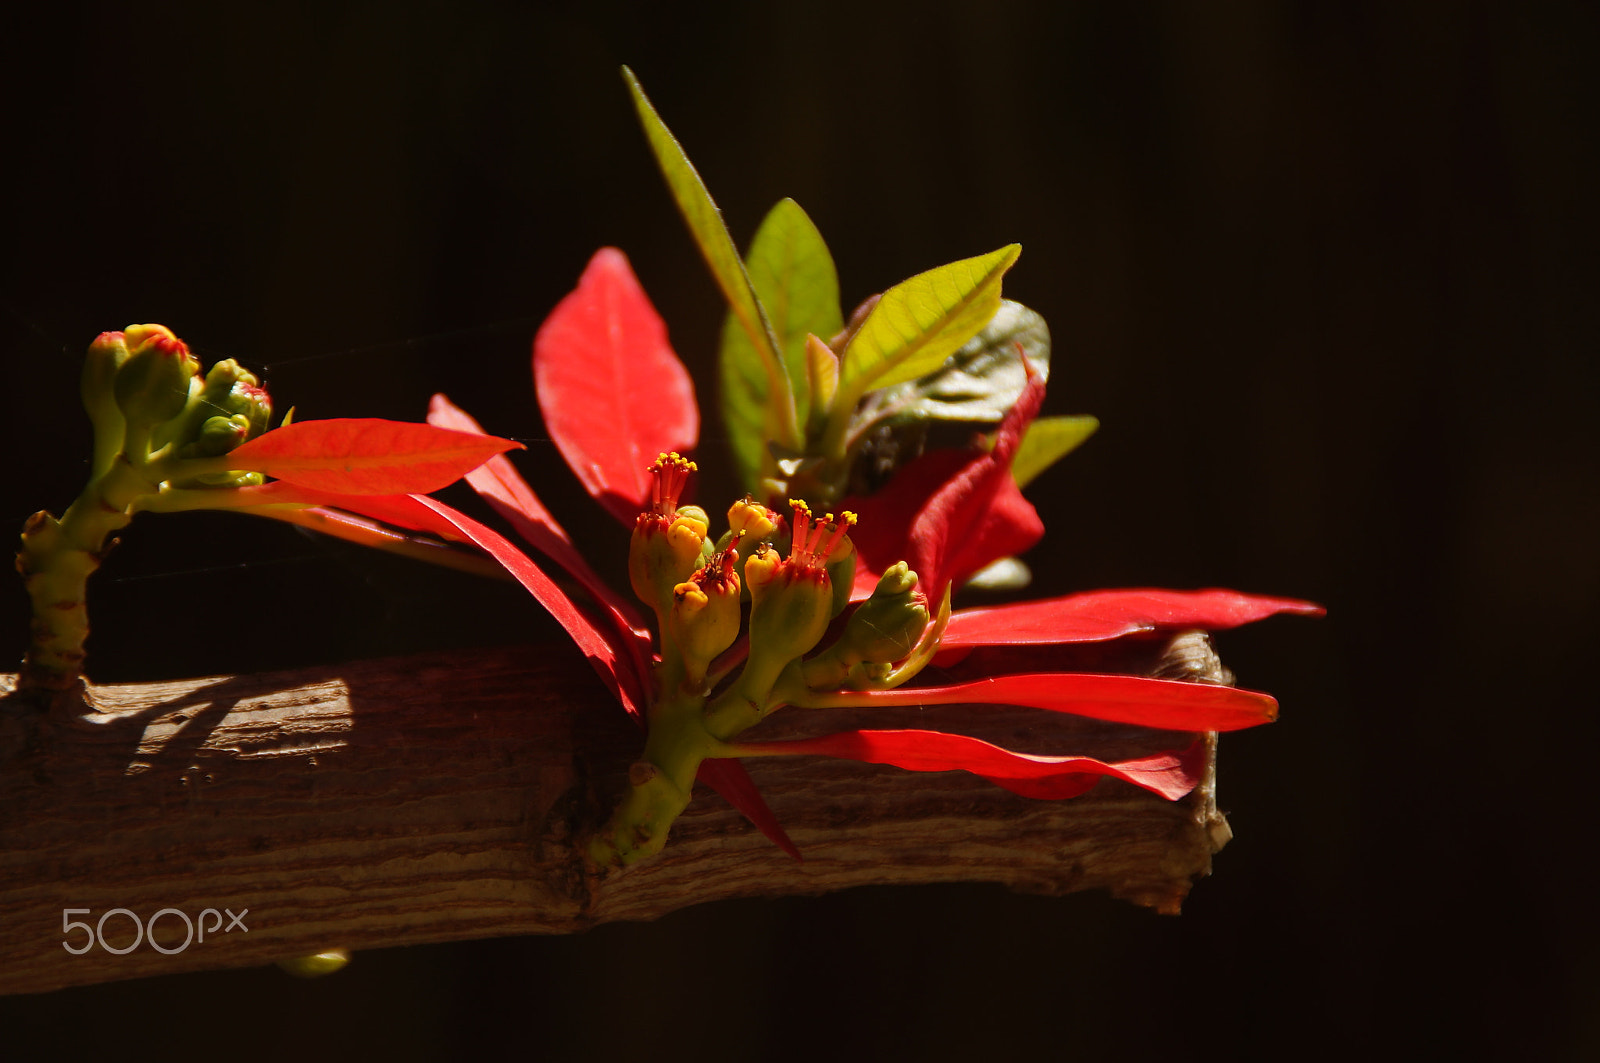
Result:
[720, 199, 843, 491]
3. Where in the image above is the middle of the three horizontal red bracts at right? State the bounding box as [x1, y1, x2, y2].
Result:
[803, 672, 1278, 732]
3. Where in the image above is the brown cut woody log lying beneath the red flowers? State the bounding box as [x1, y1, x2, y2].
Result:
[0, 632, 1229, 993]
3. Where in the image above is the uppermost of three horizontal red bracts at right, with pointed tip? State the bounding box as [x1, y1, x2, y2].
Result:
[941, 588, 1326, 648]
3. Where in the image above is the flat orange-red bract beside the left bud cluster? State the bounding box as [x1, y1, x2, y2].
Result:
[227, 418, 522, 495]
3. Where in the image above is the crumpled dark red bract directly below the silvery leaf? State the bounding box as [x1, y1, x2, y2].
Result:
[842, 375, 1045, 602]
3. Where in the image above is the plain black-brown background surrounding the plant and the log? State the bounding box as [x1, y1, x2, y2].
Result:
[0, 0, 1600, 1061]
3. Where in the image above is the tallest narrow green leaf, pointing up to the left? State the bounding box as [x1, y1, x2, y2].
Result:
[622, 67, 797, 439]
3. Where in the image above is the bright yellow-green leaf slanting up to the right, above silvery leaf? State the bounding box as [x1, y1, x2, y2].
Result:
[838, 243, 1022, 402]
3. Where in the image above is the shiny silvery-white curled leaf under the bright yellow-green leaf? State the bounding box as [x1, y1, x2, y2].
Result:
[850, 299, 1050, 439]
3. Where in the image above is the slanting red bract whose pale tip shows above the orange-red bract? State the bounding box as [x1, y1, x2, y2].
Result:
[427, 395, 650, 685]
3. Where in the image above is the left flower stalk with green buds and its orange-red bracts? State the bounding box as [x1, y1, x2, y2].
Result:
[16, 325, 514, 692]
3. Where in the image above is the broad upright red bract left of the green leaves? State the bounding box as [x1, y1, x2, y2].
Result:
[533, 248, 699, 525]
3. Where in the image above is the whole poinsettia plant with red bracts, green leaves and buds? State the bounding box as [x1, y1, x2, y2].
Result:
[19, 72, 1322, 866]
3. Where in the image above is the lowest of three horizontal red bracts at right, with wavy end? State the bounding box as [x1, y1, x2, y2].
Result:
[736, 730, 1205, 800]
